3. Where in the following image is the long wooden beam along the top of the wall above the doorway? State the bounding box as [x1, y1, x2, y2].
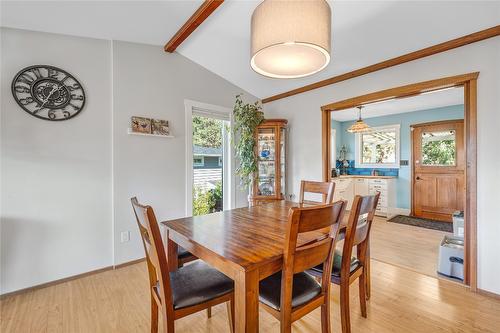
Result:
[262, 25, 500, 103]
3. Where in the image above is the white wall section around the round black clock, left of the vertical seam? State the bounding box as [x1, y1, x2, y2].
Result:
[0, 28, 113, 293]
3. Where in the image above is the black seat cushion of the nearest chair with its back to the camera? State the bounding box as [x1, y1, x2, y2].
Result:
[259, 271, 321, 311]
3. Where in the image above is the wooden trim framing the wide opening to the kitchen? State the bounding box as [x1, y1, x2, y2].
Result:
[321, 72, 479, 292]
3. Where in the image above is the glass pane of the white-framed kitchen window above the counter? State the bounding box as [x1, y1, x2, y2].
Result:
[360, 129, 396, 164]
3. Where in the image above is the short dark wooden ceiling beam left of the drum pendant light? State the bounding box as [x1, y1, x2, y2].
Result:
[164, 0, 224, 53]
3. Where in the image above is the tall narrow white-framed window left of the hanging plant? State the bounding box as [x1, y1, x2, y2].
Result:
[185, 100, 235, 216]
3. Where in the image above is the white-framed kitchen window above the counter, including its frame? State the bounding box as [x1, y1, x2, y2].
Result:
[356, 125, 399, 168]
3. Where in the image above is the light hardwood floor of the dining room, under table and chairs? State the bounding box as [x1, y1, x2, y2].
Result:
[0, 260, 500, 333]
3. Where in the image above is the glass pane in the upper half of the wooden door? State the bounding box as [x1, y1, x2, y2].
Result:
[422, 131, 457, 166]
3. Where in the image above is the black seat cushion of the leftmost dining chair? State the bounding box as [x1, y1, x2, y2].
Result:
[163, 260, 234, 310]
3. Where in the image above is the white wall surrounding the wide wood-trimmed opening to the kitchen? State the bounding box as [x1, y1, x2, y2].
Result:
[264, 37, 500, 294]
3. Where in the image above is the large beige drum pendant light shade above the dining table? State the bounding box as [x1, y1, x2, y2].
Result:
[251, 0, 331, 79]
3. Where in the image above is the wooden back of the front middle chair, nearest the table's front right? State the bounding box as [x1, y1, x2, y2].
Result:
[281, 200, 346, 309]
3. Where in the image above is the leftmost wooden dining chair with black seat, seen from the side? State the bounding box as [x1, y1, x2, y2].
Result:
[131, 197, 234, 333]
